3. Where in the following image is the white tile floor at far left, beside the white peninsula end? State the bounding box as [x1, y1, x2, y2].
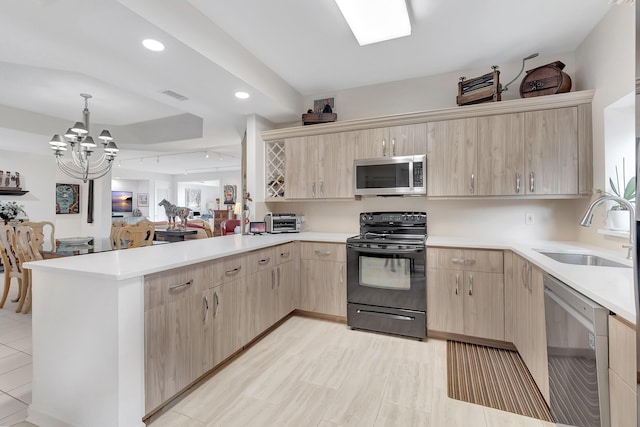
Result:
[0, 288, 32, 427]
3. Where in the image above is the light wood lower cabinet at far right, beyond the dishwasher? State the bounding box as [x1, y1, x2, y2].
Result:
[609, 315, 638, 427]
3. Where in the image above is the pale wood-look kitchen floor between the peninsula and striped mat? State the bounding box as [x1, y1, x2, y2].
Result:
[149, 317, 554, 427]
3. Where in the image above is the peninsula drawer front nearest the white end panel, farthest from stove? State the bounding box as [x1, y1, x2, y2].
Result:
[144, 262, 212, 311]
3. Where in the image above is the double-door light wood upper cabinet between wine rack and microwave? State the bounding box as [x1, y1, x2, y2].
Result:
[285, 132, 355, 199]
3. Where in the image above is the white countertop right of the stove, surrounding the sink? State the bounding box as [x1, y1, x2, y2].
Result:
[427, 236, 636, 325]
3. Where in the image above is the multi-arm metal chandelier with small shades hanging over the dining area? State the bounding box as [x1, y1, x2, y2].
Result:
[49, 93, 118, 182]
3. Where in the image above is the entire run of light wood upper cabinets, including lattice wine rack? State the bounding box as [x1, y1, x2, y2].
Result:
[262, 91, 593, 201]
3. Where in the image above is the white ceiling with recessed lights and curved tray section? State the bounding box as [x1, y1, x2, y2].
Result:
[0, 0, 611, 174]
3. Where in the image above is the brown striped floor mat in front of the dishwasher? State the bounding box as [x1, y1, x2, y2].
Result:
[447, 341, 553, 422]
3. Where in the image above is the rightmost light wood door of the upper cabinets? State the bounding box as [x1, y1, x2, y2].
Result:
[524, 107, 578, 195]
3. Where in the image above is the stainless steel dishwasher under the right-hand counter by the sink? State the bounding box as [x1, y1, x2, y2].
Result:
[544, 275, 610, 427]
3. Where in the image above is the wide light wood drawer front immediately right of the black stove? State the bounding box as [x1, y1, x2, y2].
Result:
[427, 248, 504, 273]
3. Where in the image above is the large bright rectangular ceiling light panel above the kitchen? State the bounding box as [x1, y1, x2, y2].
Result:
[336, 0, 411, 46]
